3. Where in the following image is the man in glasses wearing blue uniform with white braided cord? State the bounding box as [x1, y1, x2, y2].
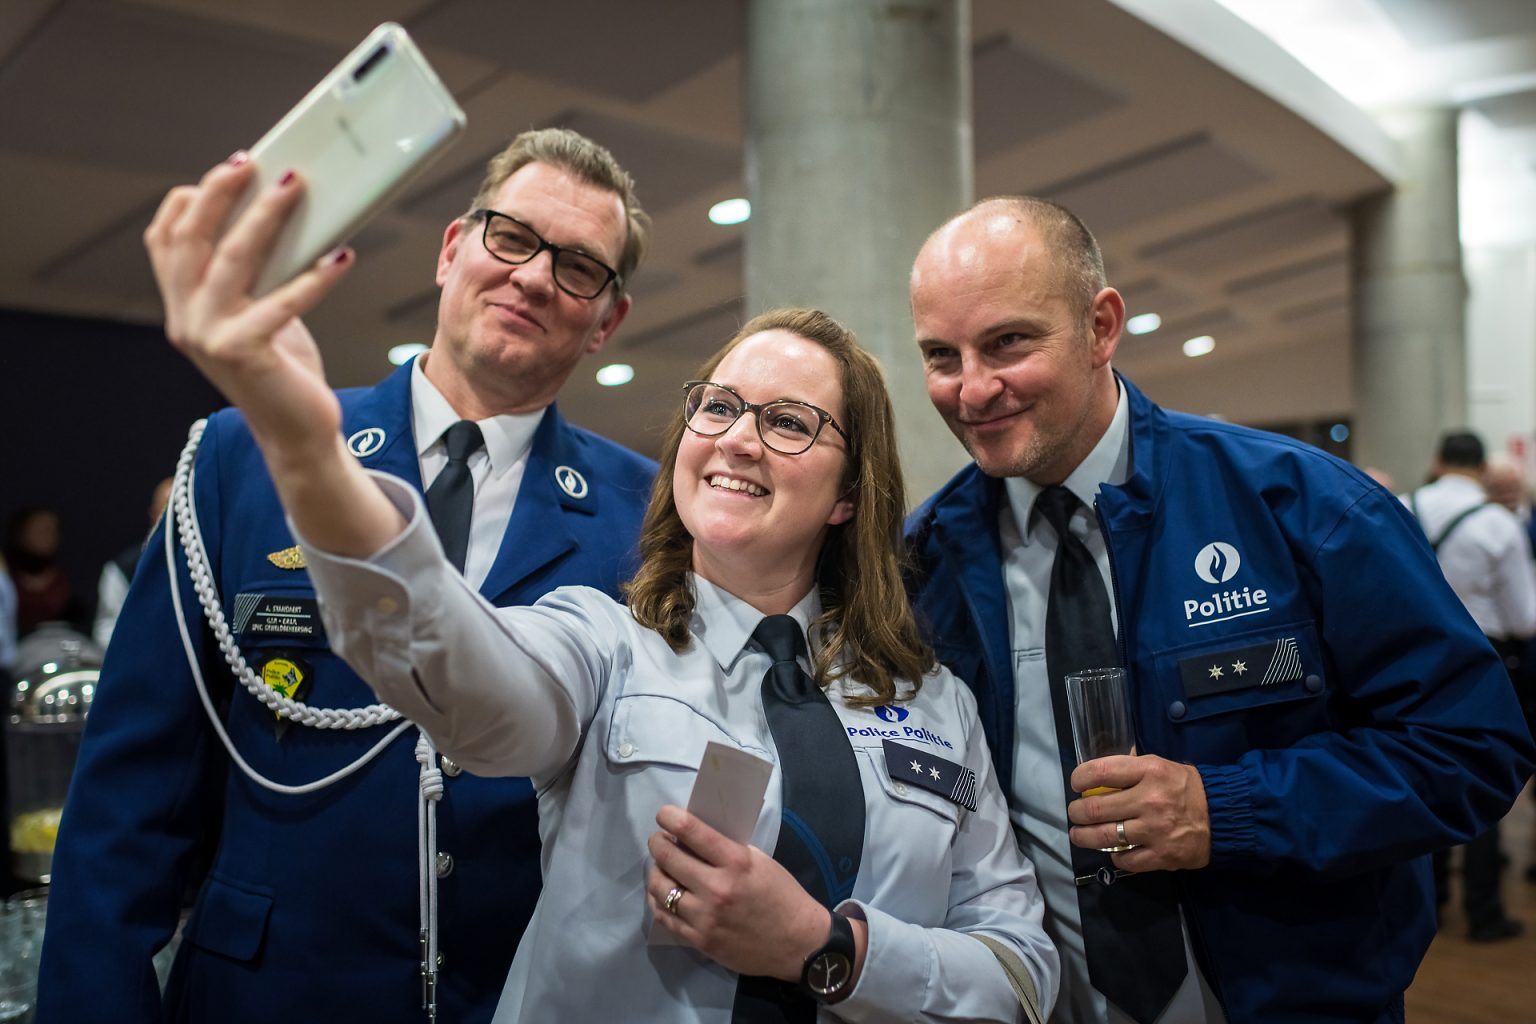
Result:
[38, 129, 654, 1024]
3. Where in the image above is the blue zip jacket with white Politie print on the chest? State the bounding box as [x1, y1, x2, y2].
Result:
[908, 378, 1533, 1024]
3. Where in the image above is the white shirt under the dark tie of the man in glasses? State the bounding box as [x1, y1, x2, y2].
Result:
[410, 353, 545, 588]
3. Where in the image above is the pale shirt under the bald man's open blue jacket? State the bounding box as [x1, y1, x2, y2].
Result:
[998, 388, 1226, 1024]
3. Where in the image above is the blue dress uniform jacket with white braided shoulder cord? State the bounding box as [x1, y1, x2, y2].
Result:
[38, 365, 654, 1024]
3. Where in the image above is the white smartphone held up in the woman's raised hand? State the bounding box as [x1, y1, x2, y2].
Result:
[227, 23, 464, 296]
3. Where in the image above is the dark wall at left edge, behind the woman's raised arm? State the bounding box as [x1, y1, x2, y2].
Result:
[0, 310, 224, 620]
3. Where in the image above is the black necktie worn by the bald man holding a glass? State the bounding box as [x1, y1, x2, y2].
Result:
[1035, 487, 1187, 1024]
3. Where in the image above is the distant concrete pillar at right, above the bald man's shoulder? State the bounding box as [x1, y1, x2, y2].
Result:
[1353, 107, 1467, 490]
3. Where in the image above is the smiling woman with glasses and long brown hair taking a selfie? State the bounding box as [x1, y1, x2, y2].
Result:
[147, 160, 1057, 1024]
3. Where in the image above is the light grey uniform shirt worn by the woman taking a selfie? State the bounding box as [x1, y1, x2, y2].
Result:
[301, 474, 1057, 1024]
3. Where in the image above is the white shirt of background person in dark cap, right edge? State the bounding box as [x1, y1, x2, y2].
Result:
[1404, 473, 1536, 640]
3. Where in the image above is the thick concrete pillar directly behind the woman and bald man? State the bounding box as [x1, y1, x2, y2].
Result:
[745, 0, 972, 504]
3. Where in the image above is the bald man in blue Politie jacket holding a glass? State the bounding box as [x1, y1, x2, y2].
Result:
[909, 198, 1533, 1024]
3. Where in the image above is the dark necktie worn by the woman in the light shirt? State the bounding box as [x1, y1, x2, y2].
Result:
[731, 616, 865, 1024]
